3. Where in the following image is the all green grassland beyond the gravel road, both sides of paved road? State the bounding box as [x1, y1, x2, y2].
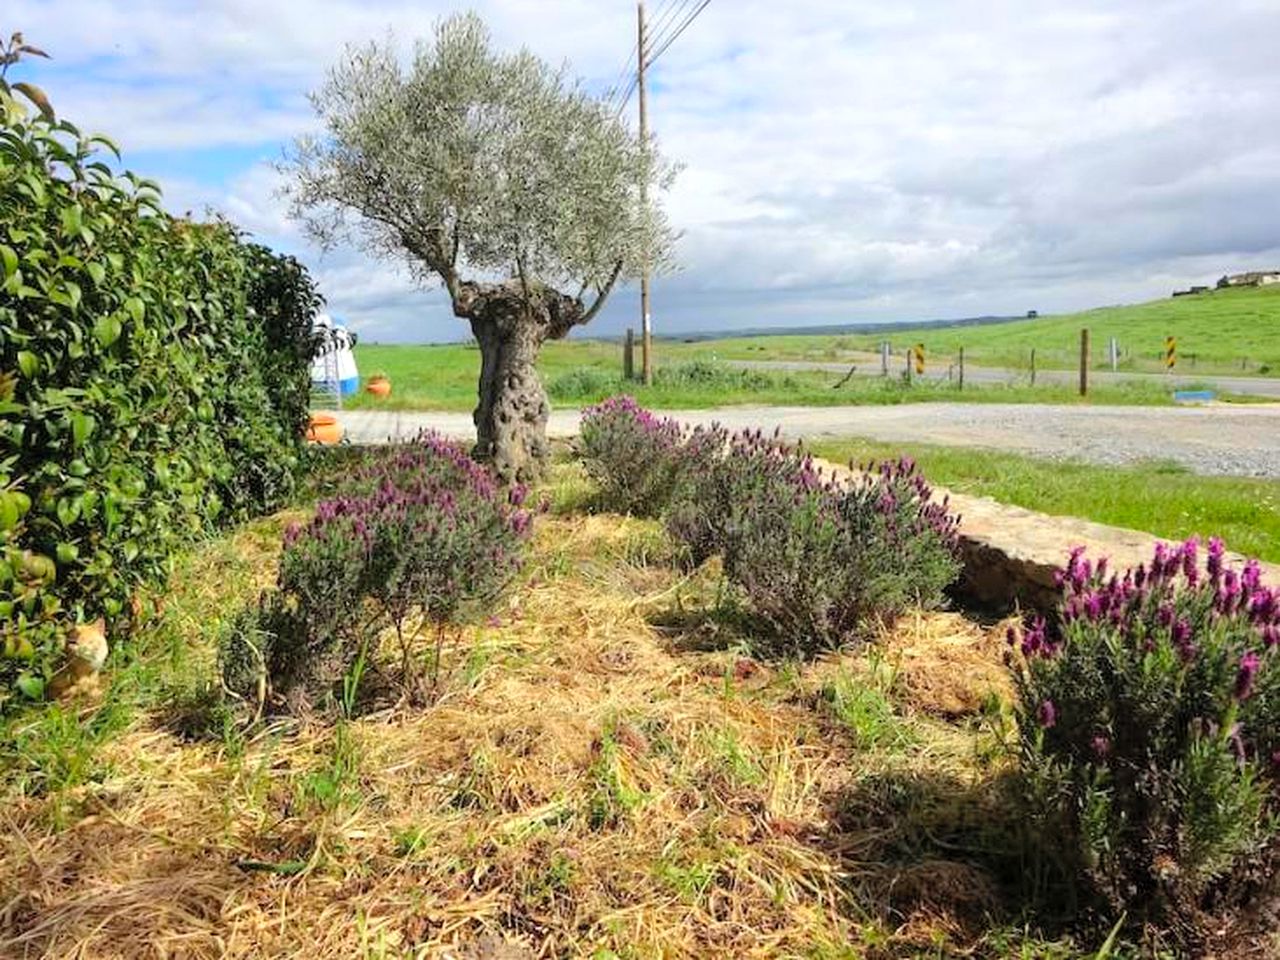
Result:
[348, 287, 1280, 411]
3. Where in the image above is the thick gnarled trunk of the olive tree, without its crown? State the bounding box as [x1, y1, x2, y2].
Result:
[453, 282, 584, 483]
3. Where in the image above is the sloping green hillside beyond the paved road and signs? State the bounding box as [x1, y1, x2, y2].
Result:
[686, 285, 1280, 375]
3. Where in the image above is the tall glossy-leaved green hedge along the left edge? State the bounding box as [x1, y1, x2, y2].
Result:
[0, 99, 320, 707]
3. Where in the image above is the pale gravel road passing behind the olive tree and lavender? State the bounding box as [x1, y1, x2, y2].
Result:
[338, 403, 1280, 477]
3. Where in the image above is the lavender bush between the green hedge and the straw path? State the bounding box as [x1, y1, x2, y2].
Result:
[223, 434, 530, 703]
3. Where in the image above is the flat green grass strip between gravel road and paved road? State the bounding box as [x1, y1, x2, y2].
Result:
[344, 340, 1187, 411]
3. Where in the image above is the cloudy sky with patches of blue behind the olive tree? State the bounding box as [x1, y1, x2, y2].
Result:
[10, 0, 1280, 342]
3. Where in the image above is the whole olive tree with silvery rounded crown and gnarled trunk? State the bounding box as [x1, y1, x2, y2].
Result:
[283, 14, 673, 480]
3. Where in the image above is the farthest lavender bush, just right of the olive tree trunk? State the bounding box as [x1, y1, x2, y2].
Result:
[580, 397, 682, 517]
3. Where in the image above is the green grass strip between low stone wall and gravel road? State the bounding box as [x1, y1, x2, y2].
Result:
[813, 440, 1280, 563]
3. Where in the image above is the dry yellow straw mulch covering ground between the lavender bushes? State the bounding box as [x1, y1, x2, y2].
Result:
[0, 506, 1018, 957]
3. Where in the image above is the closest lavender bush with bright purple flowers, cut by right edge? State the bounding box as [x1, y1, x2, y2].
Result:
[1009, 539, 1280, 924]
